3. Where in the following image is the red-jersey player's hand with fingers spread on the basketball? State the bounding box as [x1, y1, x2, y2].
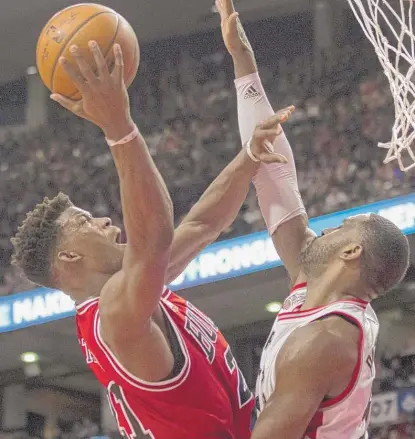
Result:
[51, 41, 132, 140]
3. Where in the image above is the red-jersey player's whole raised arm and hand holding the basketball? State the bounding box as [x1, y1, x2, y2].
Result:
[52, 42, 173, 337]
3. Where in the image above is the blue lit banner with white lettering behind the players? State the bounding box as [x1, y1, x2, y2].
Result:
[0, 194, 415, 333]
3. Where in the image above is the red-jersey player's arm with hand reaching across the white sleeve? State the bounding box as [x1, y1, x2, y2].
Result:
[166, 107, 294, 283]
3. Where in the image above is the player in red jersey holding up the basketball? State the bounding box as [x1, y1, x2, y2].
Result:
[13, 42, 292, 439]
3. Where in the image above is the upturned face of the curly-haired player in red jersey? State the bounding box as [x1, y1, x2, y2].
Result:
[58, 207, 125, 274]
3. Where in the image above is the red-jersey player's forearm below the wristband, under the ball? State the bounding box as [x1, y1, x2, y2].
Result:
[106, 124, 173, 254]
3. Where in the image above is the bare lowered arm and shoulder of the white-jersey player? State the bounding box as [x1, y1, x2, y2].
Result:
[251, 317, 359, 439]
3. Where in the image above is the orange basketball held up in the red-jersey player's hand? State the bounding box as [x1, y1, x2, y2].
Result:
[36, 3, 140, 100]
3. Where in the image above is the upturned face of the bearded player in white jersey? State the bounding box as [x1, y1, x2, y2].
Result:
[300, 215, 368, 275]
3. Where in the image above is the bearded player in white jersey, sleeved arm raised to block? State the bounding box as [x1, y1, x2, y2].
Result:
[216, 0, 409, 439]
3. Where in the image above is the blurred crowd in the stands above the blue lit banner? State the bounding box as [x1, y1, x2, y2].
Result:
[0, 14, 413, 295]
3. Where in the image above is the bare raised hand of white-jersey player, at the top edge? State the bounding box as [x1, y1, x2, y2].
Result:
[216, 0, 252, 56]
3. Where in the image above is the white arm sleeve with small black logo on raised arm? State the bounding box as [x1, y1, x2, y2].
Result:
[235, 73, 306, 235]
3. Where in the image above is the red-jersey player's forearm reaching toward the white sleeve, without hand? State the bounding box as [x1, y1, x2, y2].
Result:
[183, 150, 259, 235]
